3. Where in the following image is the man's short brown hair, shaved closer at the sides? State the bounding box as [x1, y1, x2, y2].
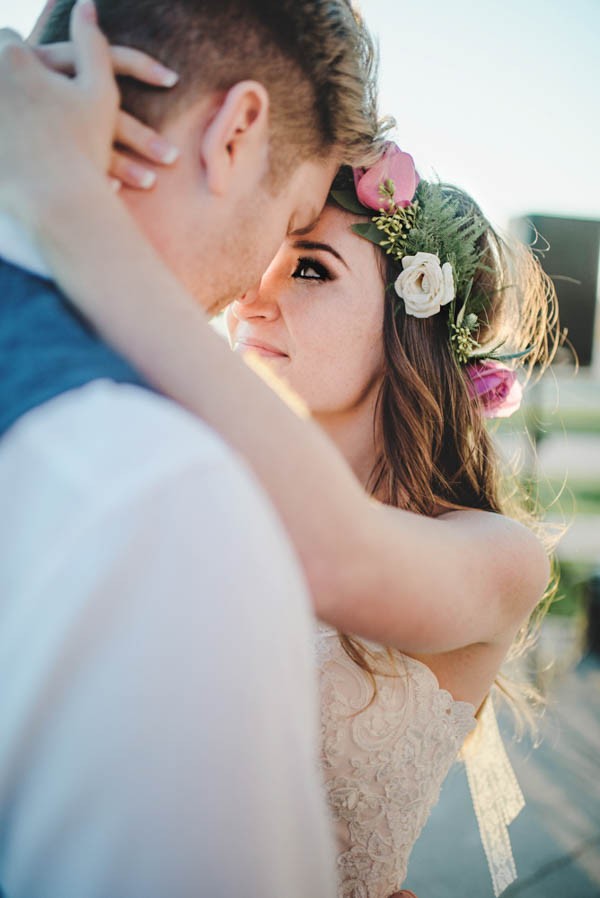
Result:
[42, 0, 379, 177]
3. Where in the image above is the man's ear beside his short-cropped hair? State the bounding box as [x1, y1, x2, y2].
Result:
[200, 81, 269, 196]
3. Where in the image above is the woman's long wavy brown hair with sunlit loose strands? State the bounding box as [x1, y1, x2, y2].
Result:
[340, 185, 561, 718]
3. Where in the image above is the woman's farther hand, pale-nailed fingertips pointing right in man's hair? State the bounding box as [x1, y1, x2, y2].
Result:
[27, 0, 178, 189]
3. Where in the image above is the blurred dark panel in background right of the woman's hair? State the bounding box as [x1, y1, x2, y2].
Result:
[511, 215, 600, 367]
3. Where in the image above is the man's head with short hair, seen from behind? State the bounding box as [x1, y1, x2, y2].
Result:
[44, 0, 377, 305]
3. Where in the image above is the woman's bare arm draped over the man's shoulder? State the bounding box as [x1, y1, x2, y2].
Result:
[0, 26, 547, 652]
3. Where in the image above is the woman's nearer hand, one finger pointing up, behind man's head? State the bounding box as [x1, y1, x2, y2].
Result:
[0, 0, 119, 224]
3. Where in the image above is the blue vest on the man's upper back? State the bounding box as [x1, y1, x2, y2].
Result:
[0, 259, 150, 438]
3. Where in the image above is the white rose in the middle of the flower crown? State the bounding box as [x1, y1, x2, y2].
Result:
[394, 253, 456, 318]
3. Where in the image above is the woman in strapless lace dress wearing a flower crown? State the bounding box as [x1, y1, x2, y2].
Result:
[2, 8, 556, 898]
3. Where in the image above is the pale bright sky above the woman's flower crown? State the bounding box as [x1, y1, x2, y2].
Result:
[0, 0, 600, 233]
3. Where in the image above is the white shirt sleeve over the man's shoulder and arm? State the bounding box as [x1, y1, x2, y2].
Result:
[0, 226, 335, 898]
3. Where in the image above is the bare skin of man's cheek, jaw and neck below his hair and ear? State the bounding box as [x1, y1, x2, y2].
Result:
[121, 112, 339, 315]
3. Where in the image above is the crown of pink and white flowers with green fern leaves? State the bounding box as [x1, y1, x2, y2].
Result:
[331, 142, 531, 417]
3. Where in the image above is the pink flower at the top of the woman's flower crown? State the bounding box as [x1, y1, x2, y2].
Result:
[354, 140, 420, 212]
